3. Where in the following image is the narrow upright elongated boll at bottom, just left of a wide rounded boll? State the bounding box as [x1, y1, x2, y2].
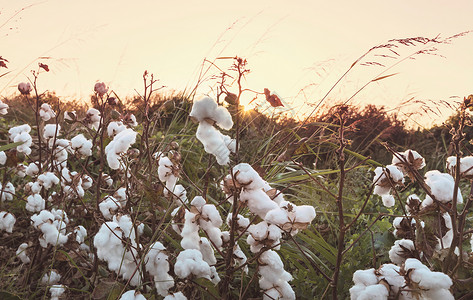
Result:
[144, 242, 174, 297]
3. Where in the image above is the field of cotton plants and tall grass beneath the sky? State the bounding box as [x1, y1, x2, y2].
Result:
[0, 38, 473, 299]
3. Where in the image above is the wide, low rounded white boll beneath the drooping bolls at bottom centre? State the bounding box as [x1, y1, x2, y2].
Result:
[174, 249, 212, 280]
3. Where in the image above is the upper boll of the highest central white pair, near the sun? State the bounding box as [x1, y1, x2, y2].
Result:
[189, 97, 233, 130]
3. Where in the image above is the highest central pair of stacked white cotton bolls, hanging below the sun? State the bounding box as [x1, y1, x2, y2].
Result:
[189, 97, 236, 165]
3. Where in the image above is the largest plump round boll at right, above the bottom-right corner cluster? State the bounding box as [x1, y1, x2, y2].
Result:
[423, 170, 463, 206]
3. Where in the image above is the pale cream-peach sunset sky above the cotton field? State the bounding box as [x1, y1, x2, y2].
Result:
[0, 0, 473, 124]
